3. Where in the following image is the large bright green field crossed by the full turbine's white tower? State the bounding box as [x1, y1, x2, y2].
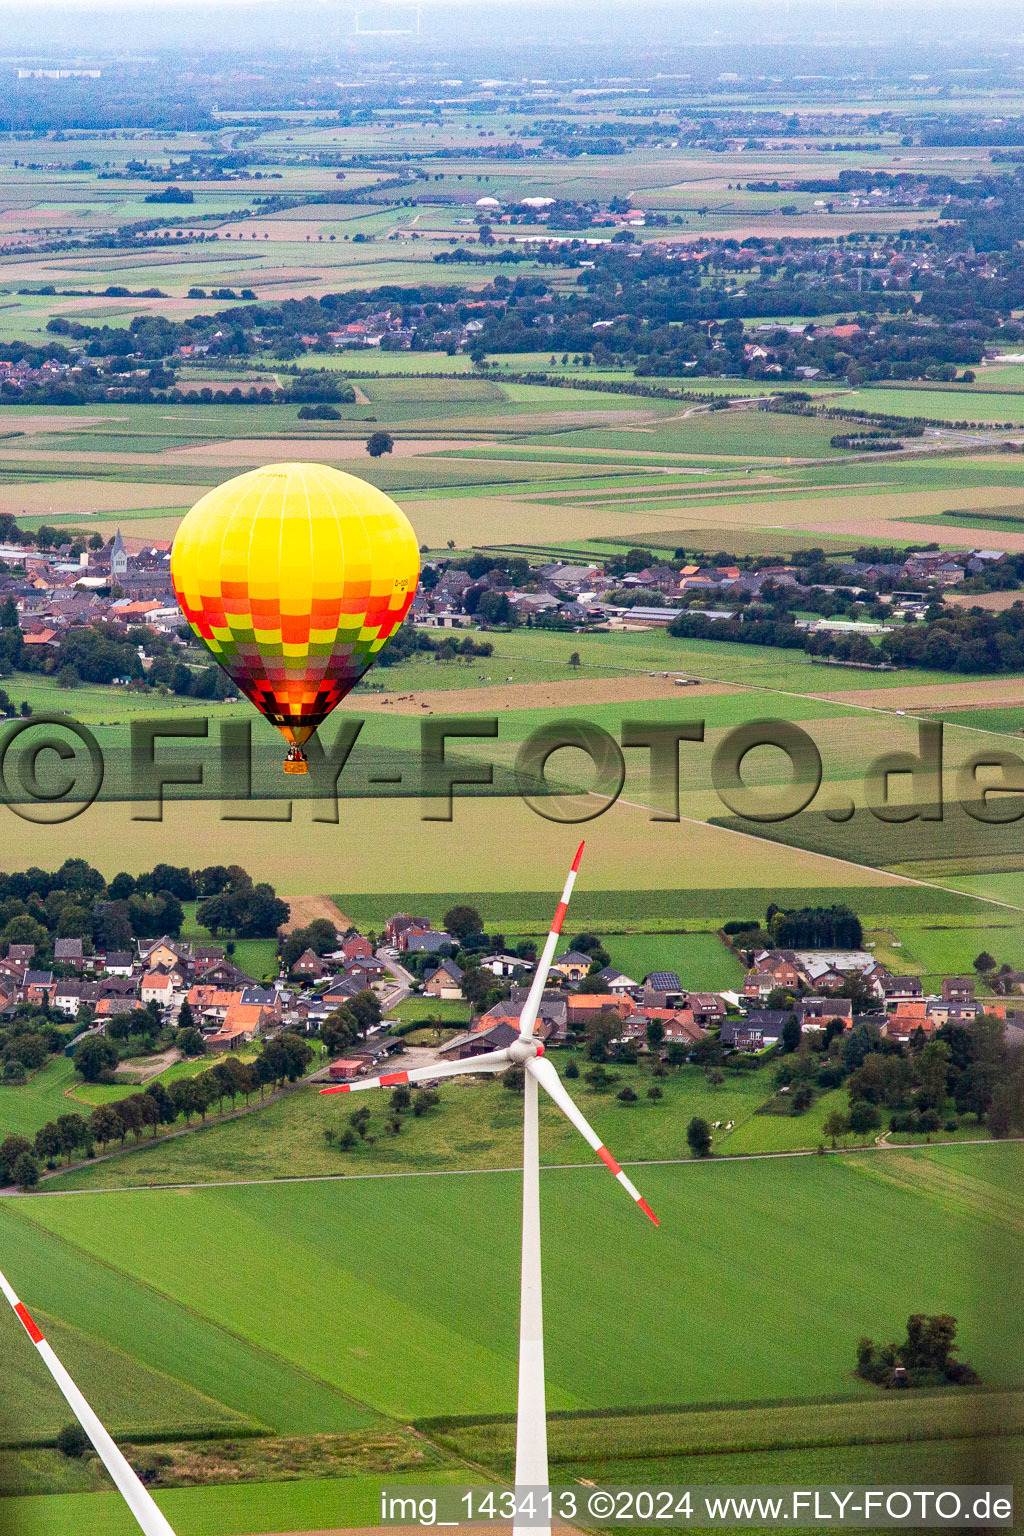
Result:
[3, 1144, 1024, 1421]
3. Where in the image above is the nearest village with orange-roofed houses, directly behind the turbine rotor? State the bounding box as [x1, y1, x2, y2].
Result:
[0, 912, 1024, 1081]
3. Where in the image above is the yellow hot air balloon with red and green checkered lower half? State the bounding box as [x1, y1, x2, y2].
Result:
[170, 464, 419, 773]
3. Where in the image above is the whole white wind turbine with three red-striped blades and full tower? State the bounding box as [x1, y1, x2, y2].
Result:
[321, 843, 659, 1536]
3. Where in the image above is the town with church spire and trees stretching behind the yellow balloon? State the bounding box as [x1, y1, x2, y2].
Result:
[0, 518, 1024, 699]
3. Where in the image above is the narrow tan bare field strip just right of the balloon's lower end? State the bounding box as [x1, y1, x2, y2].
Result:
[360, 664, 740, 714]
